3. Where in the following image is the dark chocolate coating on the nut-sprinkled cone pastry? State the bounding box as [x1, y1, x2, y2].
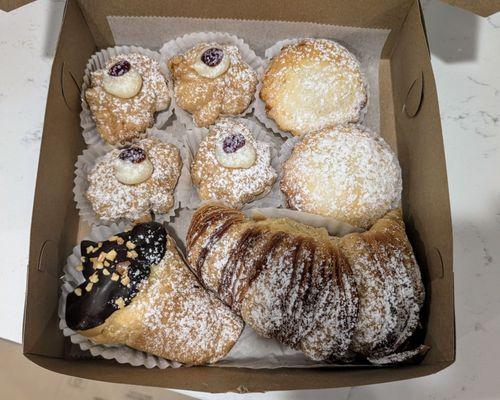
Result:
[66, 222, 167, 330]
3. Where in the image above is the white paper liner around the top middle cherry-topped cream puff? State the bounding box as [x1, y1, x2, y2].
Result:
[160, 32, 264, 127]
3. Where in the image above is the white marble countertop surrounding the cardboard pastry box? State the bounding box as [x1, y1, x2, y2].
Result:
[0, 0, 500, 400]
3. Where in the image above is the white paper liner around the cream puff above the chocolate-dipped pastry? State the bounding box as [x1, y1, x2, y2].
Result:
[73, 121, 192, 225]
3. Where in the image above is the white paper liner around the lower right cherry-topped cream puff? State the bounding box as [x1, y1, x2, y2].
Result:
[183, 118, 283, 209]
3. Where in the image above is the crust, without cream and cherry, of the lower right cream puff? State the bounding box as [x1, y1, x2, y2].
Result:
[191, 118, 276, 208]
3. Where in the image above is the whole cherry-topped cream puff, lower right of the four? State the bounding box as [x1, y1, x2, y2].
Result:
[191, 118, 276, 207]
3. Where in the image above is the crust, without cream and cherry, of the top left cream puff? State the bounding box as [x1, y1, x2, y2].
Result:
[85, 53, 170, 144]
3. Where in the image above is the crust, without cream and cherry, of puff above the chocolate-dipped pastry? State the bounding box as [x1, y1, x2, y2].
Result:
[86, 138, 182, 221]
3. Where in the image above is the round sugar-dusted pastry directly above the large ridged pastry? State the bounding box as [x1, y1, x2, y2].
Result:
[280, 125, 402, 228]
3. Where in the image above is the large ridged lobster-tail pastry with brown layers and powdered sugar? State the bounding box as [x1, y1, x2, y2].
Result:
[187, 204, 424, 361]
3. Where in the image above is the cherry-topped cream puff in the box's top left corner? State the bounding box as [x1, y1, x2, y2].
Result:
[85, 53, 170, 144]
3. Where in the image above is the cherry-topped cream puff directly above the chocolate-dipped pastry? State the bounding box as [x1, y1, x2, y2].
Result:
[86, 138, 182, 221]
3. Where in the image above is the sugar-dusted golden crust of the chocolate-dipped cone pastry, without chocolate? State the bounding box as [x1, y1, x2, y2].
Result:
[79, 238, 243, 365]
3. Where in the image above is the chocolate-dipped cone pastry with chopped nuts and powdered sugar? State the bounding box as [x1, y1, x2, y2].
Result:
[65, 222, 243, 365]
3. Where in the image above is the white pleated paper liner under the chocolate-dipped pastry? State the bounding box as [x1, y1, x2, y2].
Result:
[59, 223, 182, 369]
